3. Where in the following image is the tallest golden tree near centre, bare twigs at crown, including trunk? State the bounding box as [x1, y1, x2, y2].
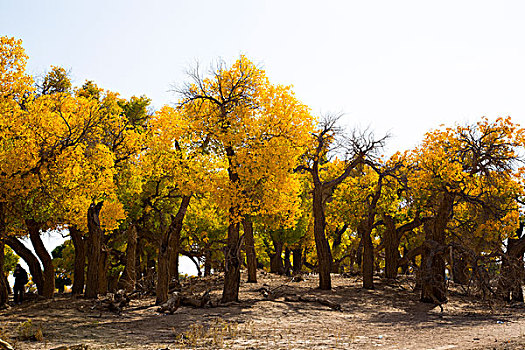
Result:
[179, 56, 311, 302]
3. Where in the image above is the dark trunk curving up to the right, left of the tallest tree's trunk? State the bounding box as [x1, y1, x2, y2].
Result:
[155, 195, 191, 305]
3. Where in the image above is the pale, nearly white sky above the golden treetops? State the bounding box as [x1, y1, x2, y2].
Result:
[0, 0, 525, 274]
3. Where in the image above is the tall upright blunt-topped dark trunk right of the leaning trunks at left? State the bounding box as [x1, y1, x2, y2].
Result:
[85, 201, 104, 298]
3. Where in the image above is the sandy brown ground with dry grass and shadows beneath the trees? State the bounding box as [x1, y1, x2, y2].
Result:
[0, 273, 525, 350]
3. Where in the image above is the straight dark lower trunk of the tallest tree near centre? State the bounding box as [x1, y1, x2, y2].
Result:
[221, 220, 242, 303]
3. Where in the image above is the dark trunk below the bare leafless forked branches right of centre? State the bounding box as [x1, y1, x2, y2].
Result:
[313, 185, 332, 290]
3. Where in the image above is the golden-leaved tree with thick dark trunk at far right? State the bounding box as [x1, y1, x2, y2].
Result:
[409, 118, 524, 303]
